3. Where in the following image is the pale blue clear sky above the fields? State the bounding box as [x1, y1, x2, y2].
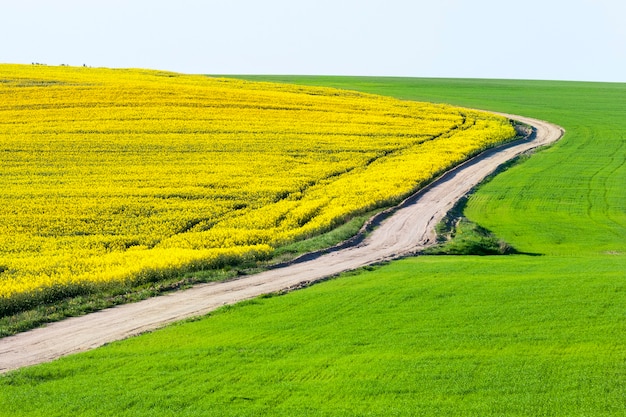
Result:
[0, 0, 626, 82]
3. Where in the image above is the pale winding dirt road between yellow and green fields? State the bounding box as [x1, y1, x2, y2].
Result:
[0, 114, 564, 373]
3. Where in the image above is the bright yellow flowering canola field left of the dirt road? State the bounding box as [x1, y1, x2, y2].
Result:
[0, 65, 515, 311]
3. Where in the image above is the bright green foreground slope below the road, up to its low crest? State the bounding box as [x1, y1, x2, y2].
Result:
[0, 257, 626, 417]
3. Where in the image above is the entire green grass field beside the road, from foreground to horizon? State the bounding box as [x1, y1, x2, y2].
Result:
[0, 77, 626, 416]
